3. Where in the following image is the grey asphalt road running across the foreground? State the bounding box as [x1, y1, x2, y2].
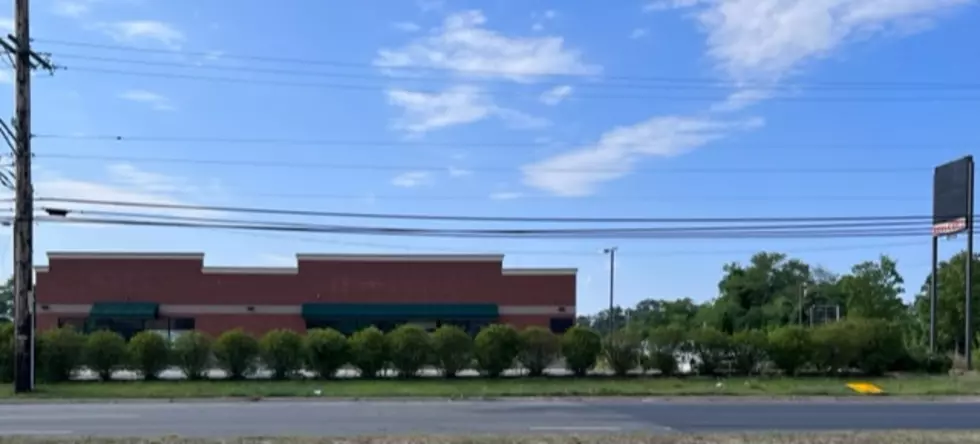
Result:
[0, 400, 980, 437]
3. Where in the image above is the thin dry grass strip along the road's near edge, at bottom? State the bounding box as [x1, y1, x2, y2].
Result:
[0, 431, 980, 444]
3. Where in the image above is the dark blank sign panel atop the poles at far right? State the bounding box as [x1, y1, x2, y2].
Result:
[932, 156, 973, 236]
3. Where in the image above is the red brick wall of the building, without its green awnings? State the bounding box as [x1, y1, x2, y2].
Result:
[36, 253, 576, 333]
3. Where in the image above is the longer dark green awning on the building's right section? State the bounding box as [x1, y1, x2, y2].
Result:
[303, 303, 499, 319]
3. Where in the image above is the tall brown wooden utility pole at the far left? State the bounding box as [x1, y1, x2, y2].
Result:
[13, 0, 34, 393]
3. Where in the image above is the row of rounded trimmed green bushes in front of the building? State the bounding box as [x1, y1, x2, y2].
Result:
[0, 320, 952, 382]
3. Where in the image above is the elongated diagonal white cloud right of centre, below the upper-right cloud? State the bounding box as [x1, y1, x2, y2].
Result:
[523, 116, 763, 196]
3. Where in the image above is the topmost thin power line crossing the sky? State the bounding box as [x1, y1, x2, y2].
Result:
[35, 39, 980, 89]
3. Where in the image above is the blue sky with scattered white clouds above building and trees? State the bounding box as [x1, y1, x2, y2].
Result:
[0, 0, 980, 313]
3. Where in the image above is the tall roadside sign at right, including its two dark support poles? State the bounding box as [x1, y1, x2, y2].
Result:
[929, 156, 974, 370]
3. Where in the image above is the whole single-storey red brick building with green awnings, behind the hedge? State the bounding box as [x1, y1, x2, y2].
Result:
[35, 252, 576, 337]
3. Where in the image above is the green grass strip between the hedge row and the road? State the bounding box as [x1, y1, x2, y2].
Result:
[0, 376, 980, 399]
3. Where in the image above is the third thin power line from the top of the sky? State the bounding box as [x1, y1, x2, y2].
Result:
[34, 133, 956, 151]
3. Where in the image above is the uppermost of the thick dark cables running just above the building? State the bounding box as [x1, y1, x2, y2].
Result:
[35, 197, 932, 226]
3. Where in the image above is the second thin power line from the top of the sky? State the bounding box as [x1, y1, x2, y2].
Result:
[57, 66, 980, 103]
